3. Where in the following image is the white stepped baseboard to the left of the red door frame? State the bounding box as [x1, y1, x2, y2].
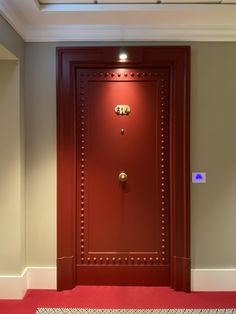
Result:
[0, 267, 56, 299]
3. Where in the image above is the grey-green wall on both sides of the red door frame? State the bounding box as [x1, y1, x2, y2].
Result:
[0, 12, 236, 272]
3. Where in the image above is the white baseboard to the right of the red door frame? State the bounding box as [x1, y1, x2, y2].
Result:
[191, 269, 236, 291]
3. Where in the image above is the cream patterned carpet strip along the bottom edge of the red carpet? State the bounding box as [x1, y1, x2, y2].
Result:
[36, 308, 236, 314]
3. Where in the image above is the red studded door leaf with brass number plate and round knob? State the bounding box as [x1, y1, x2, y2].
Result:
[76, 67, 170, 285]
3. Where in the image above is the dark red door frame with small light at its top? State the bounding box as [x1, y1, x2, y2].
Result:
[57, 46, 191, 292]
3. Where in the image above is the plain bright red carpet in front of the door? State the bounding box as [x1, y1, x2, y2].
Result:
[0, 286, 236, 314]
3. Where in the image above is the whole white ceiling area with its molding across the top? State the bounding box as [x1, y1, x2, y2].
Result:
[0, 0, 236, 41]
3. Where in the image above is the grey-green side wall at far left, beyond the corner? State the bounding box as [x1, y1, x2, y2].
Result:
[0, 16, 25, 275]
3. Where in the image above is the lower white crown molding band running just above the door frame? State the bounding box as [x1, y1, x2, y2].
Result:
[25, 25, 236, 42]
